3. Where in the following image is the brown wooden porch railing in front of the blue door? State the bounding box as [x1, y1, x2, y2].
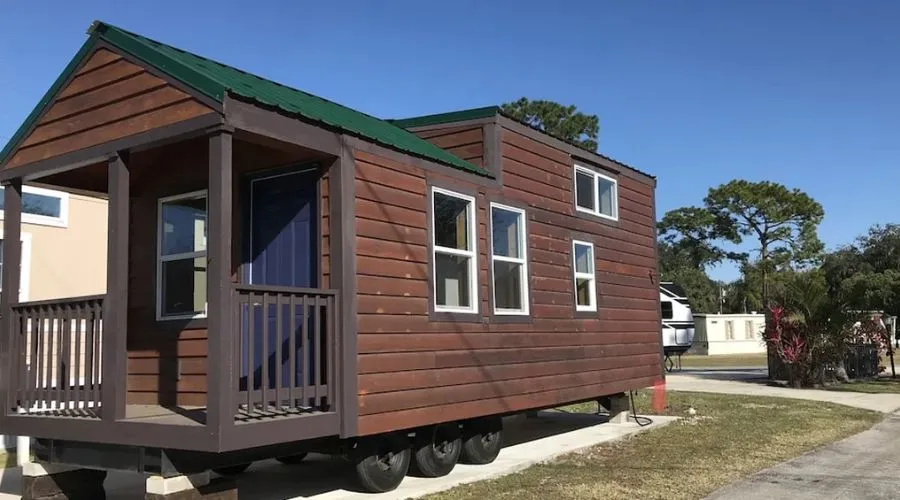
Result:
[235, 285, 338, 419]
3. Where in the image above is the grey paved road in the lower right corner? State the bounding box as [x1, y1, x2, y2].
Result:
[707, 415, 900, 500]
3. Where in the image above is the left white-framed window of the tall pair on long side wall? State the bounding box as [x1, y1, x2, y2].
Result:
[431, 187, 478, 313]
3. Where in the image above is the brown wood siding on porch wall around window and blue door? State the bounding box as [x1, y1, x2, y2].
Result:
[128, 138, 328, 406]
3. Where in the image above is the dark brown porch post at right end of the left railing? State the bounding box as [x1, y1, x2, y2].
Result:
[100, 151, 131, 422]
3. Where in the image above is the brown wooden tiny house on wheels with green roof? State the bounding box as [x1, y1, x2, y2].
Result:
[0, 22, 662, 498]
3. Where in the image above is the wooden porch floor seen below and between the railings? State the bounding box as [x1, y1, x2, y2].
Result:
[22, 404, 322, 426]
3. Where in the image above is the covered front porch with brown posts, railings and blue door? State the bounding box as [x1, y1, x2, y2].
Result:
[0, 106, 356, 452]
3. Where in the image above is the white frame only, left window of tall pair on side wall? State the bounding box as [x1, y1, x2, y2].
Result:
[428, 186, 480, 314]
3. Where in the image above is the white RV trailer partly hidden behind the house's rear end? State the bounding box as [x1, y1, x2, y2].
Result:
[659, 281, 694, 371]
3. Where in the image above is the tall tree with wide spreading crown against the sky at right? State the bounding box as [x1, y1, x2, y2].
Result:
[704, 180, 825, 305]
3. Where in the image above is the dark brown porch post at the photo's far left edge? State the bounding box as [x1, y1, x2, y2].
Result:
[0, 178, 25, 416]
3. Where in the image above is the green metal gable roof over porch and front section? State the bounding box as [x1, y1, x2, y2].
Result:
[0, 21, 492, 177]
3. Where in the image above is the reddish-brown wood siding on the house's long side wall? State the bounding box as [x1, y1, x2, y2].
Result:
[355, 125, 660, 434]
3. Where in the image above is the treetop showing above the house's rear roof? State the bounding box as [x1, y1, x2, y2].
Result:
[500, 97, 600, 151]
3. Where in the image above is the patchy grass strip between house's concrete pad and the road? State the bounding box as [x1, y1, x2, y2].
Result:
[426, 392, 882, 500]
